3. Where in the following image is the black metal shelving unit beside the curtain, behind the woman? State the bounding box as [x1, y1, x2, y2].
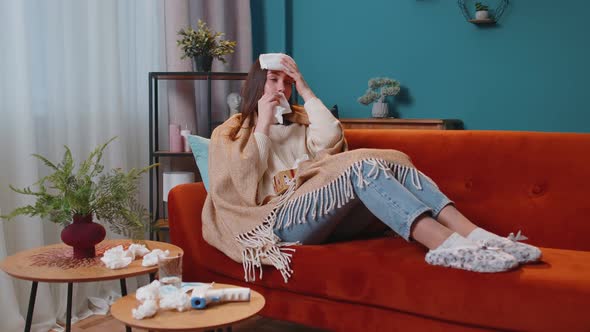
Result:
[149, 72, 248, 239]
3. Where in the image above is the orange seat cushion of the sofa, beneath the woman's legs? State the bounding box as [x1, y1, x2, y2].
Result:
[199, 238, 590, 331]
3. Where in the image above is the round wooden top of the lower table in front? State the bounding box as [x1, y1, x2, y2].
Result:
[111, 283, 265, 331]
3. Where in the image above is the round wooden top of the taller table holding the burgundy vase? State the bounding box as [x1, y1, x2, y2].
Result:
[0, 240, 183, 282]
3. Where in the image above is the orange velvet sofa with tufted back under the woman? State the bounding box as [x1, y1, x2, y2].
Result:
[168, 130, 590, 332]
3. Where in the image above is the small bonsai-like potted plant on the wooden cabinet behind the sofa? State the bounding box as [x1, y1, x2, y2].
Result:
[357, 77, 400, 118]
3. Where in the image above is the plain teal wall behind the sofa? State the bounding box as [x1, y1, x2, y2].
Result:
[251, 0, 590, 132]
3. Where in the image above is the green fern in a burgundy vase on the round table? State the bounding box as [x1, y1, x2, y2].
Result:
[0, 137, 157, 258]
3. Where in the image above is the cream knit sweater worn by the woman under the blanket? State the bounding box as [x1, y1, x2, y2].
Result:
[254, 98, 342, 203]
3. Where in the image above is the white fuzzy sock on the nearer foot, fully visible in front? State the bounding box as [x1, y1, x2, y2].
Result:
[425, 233, 518, 272]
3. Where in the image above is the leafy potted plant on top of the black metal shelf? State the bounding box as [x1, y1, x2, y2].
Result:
[176, 20, 237, 72]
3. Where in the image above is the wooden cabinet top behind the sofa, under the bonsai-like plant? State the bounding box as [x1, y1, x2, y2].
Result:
[340, 118, 463, 130]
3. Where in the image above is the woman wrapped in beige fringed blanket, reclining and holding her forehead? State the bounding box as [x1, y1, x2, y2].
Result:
[203, 54, 541, 281]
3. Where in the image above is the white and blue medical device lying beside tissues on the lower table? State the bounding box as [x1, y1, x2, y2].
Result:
[191, 283, 250, 309]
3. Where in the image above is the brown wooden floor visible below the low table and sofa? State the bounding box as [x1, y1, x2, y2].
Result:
[62, 315, 323, 332]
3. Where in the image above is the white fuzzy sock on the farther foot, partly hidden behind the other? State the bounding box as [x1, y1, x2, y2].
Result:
[467, 227, 542, 263]
